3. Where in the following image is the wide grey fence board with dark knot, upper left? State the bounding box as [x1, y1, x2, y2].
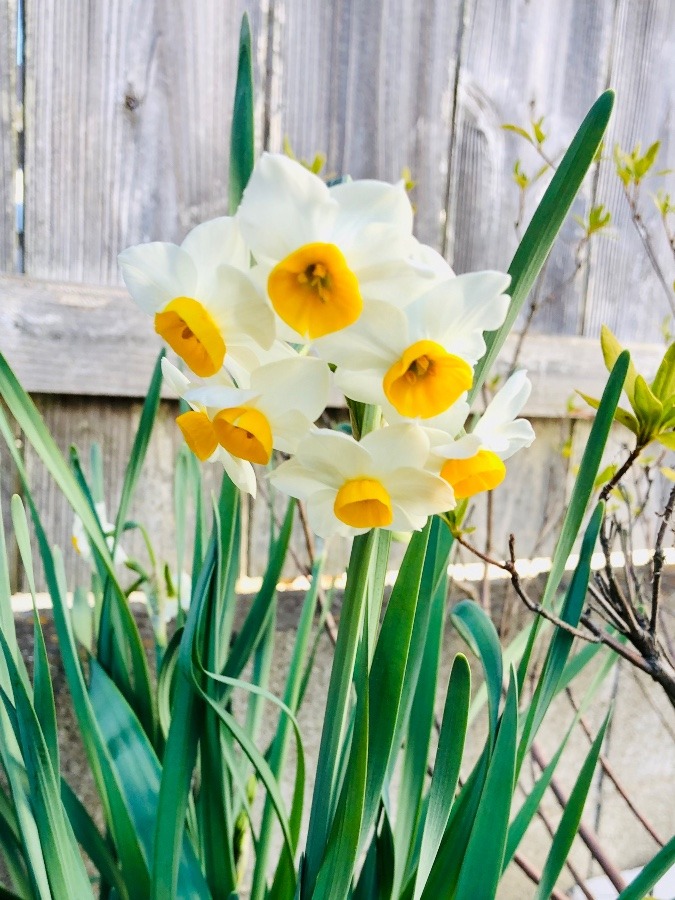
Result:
[26, 0, 264, 284]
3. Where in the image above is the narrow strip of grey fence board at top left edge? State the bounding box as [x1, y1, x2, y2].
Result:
[0, 0, 19, 272]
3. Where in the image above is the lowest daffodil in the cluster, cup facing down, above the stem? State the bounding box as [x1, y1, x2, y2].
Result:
[270, 424, 455, 538]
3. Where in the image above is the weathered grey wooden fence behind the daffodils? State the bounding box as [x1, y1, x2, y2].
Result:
[0, 0, 675, 585]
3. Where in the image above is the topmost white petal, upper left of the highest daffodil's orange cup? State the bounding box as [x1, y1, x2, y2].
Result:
[236, 153, 338, 262]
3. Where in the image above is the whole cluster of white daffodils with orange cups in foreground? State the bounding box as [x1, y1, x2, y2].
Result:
[120, 154, 534, 537]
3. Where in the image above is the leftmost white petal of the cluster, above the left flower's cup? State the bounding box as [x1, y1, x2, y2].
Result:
[117, 241, 197, 315]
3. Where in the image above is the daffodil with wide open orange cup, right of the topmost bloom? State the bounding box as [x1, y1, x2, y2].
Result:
[316, 272, 509, 421]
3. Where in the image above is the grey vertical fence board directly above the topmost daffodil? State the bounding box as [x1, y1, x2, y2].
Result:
[269, 0, 464, 247]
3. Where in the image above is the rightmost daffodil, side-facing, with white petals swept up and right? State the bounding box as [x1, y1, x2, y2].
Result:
[428, 371, 535, 500]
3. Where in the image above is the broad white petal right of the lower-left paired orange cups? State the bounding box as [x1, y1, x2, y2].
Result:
[251, 356, 330, 422]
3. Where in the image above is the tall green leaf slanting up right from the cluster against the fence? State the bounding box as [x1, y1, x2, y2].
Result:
[469, 91, 614, 401]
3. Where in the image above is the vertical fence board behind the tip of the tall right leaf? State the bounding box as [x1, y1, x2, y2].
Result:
[447, 0, 613, 334]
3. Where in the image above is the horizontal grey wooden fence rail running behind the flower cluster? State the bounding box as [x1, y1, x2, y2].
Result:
[0, 276, 663, 417]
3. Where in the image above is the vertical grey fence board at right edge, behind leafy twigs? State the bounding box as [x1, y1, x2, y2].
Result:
[583, 0, 675, 341]
